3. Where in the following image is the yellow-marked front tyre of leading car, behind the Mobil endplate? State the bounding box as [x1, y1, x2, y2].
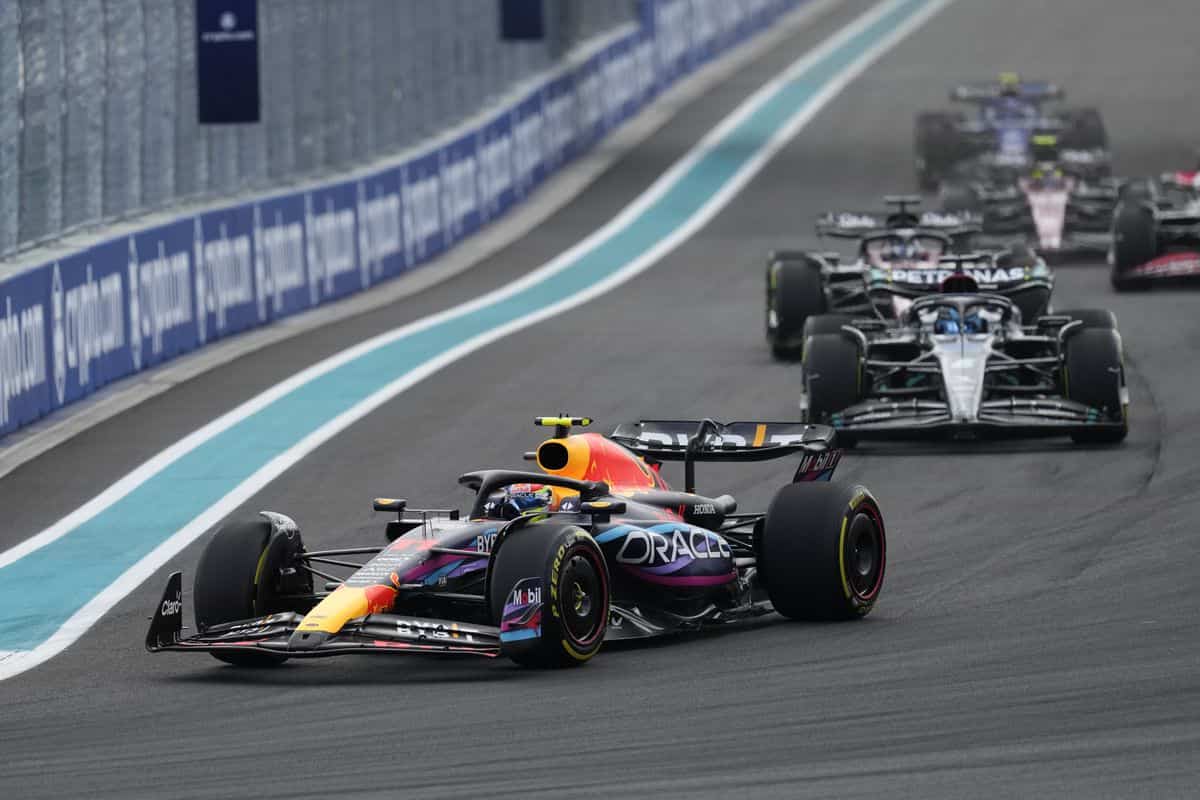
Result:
[487, 521, 611, 668]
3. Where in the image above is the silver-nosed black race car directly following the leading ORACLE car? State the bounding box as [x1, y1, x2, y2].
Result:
[800, 271, 1129, 446]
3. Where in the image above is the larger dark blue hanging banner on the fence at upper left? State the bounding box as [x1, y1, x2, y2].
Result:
[196, 0, 260, 125]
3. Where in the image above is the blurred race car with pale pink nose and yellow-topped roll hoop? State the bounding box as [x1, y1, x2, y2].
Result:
[940, 136, 1121, 255]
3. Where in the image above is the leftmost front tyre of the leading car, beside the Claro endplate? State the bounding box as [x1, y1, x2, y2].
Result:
[193, 518, 299, 667]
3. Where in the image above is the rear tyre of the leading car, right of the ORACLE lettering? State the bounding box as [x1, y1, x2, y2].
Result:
[758, 482, 887, 620]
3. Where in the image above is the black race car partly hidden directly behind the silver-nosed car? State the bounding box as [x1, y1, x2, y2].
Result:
[767, 196, 1054, 359]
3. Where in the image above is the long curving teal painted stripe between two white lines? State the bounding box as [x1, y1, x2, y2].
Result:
[0, 0, 930, 650]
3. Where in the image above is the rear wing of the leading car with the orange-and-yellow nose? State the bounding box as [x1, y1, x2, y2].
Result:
[608, 419, 841, 492]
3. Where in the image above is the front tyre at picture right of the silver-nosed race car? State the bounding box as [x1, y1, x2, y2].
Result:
[1062, 327, 1129, 444]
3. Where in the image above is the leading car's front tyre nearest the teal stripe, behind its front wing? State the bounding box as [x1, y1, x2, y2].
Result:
[193, 517, 312, 667]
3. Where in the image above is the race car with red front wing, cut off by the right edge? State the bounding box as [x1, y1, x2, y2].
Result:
[1109, 172, 1200, 291]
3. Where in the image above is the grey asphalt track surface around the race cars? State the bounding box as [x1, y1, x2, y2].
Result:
[0, 0, 1200, 798]
